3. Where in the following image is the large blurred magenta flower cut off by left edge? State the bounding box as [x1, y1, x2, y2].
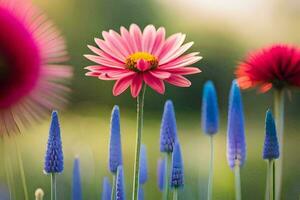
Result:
[0, 0, 72, 135]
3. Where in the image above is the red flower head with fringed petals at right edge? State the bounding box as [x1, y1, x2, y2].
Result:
[236, 44, 300, 92]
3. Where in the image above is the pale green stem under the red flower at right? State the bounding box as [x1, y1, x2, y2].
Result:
[274, 90, 284, 200]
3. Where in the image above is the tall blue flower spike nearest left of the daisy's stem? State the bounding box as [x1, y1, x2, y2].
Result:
[109, 106, 122, 173]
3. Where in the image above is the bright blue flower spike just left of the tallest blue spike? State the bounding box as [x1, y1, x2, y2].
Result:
[202, 81, 219, 135]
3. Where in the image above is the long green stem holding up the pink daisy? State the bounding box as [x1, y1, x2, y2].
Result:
[132, 85, 146, 200]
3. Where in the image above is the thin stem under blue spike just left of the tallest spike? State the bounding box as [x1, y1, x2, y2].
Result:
[207, 135, 214, 200]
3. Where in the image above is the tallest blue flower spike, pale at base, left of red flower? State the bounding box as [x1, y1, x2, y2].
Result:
[227, 80, 246, 168]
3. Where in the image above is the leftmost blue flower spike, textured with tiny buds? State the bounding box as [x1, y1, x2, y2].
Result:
[44, 111, 64, 174]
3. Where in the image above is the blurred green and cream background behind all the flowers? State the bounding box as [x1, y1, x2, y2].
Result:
[0, 0, 300, 200]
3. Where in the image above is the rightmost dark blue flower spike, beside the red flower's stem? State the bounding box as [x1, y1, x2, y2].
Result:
[263, 110, 279, 159]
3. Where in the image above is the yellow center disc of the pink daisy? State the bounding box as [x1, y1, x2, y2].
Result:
[125, 52, 158, 71]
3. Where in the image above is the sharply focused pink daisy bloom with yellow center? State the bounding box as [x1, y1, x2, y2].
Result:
[86, 24, 201, 97]
